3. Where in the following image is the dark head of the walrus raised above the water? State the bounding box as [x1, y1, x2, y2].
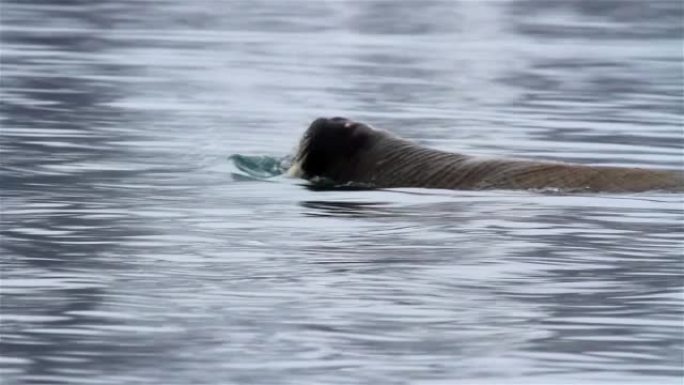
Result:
[288, 117, 376, 181]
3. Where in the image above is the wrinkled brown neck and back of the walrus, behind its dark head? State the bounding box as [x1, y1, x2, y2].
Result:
[356, 134, 684, 192]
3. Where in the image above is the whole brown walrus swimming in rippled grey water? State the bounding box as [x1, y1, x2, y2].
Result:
[288, 117, 684, 192]
